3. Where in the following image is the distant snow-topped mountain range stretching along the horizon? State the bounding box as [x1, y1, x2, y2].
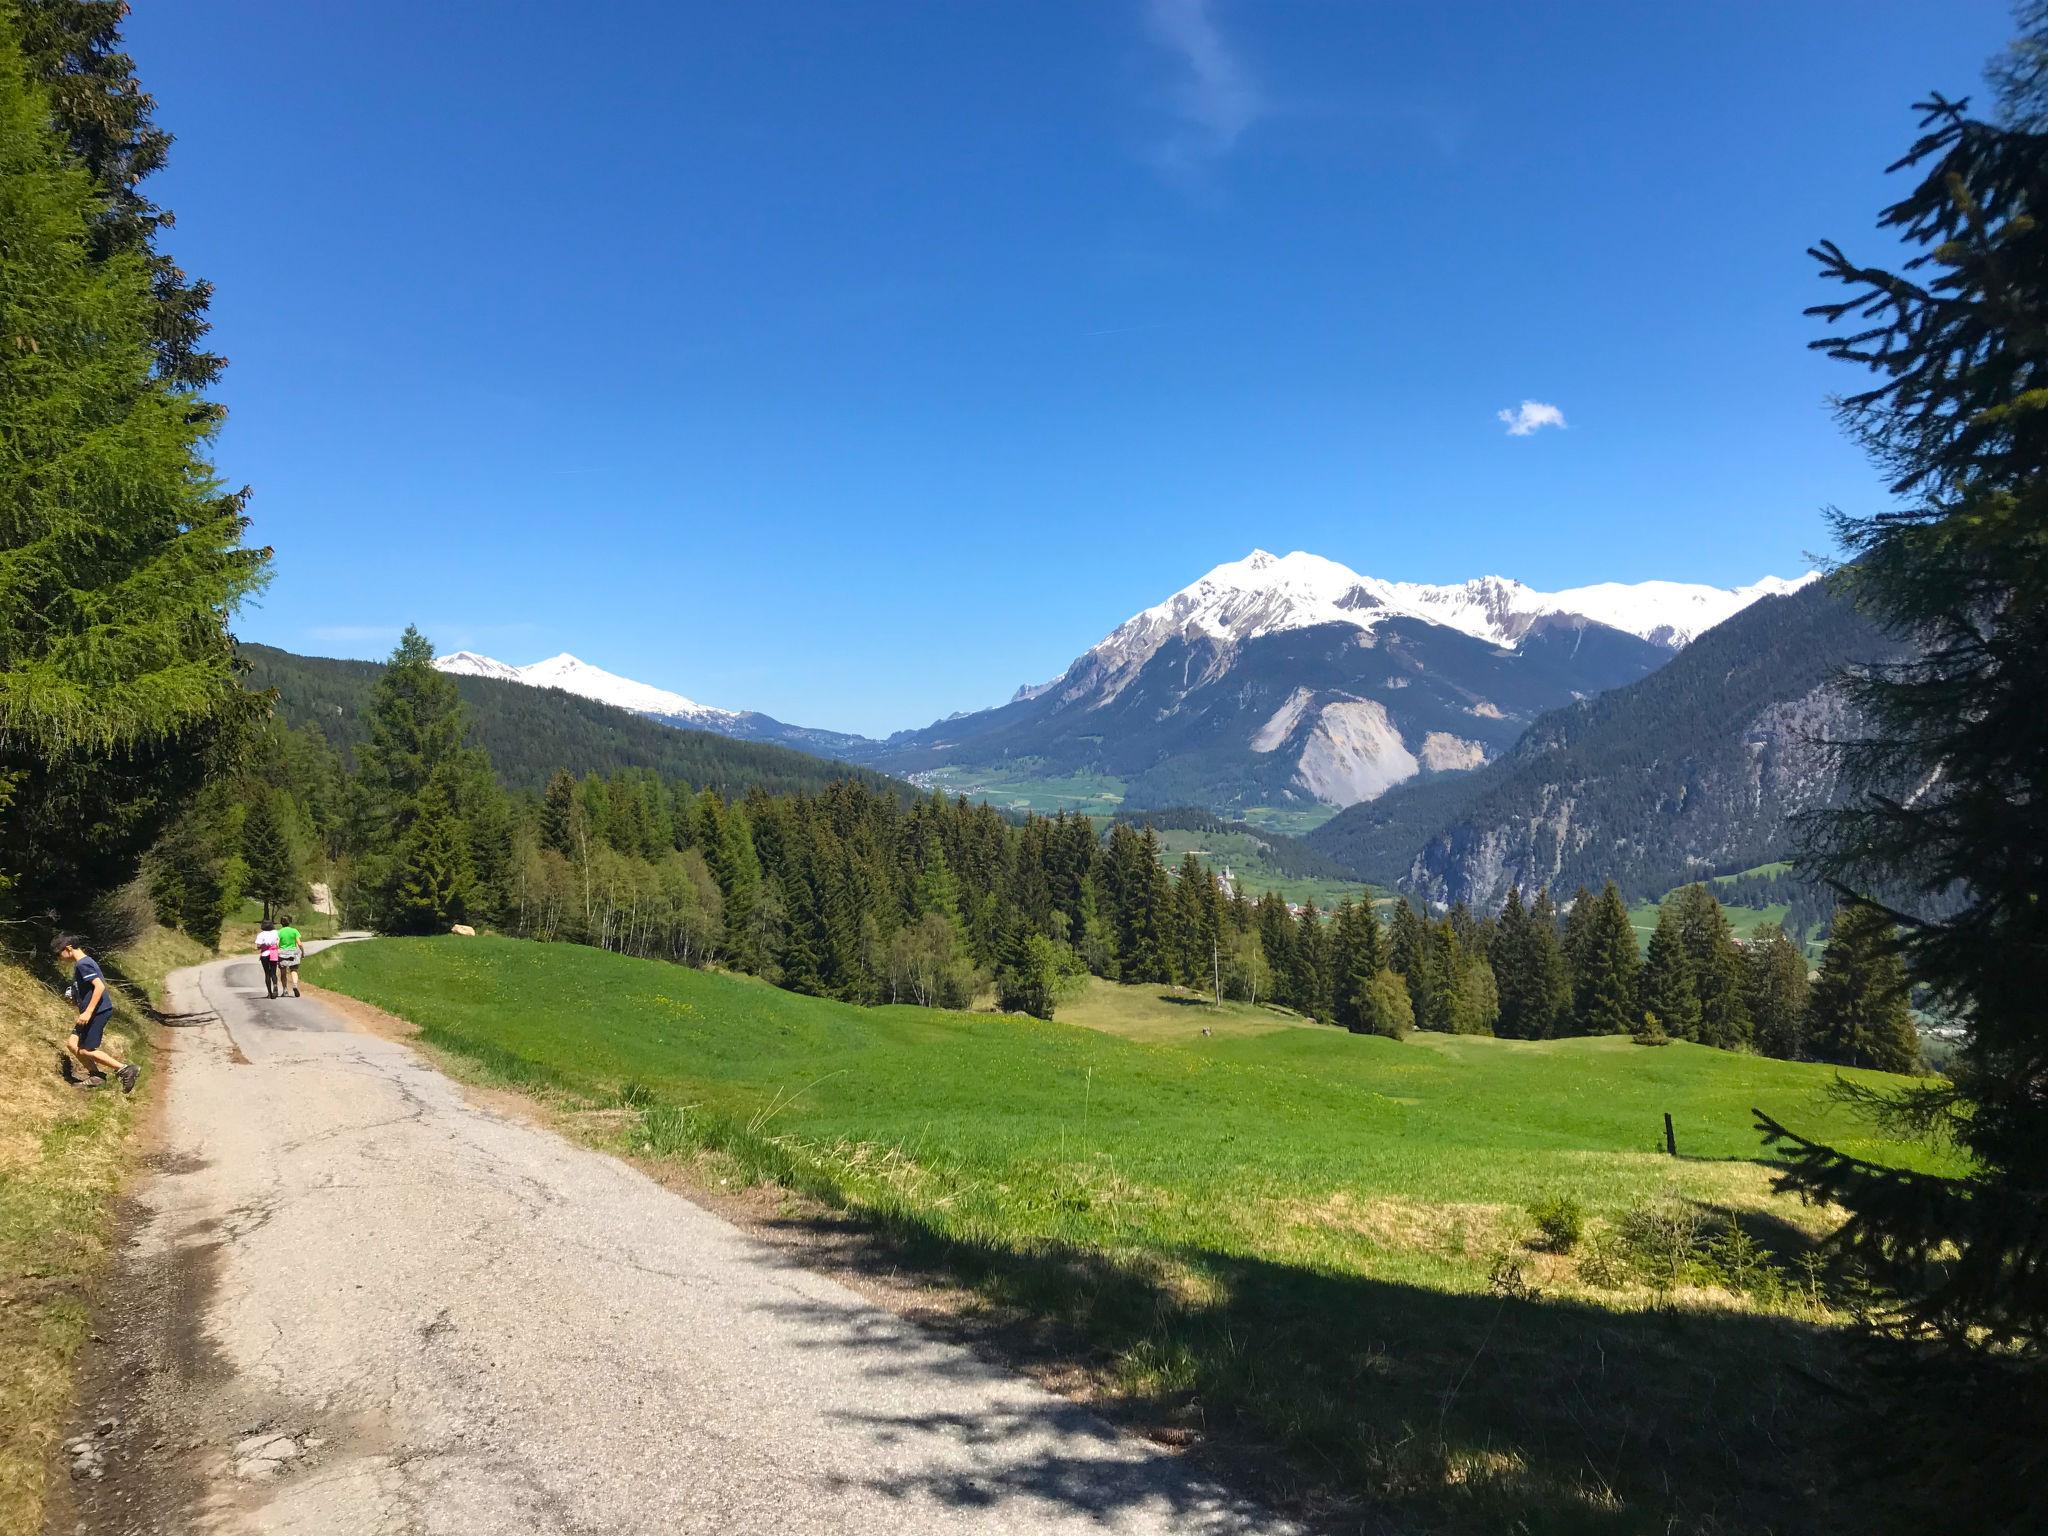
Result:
[436, 551, 1812, 811]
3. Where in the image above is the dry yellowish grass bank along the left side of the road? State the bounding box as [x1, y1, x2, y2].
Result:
[0, 930, 207, 1532]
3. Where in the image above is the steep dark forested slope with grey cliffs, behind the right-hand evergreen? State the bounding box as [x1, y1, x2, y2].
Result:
[1309, 586, 1892, 909]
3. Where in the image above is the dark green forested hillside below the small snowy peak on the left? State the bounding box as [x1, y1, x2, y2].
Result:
[240, 643, 911, 795]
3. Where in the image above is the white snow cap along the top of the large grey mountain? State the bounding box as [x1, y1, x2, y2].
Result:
[1087, 549, 1819, 700]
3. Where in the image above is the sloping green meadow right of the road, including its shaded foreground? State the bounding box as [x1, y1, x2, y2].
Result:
[309, 938, 1966, 1534]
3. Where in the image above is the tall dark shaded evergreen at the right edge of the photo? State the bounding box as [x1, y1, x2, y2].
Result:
[1761, 30, 2048, 1356]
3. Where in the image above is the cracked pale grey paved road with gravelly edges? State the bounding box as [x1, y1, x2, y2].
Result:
[82, 961, 1288, 1536]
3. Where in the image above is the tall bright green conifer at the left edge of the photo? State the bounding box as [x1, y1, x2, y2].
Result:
[0, 10, 266, 911]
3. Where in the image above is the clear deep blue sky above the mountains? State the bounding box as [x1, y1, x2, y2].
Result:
[127, 0, 2011, 731]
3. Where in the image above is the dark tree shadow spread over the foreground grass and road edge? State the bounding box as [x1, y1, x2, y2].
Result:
[737, 1187, 1966, 1536]
